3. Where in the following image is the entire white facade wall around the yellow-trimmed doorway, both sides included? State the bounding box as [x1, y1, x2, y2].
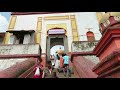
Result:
[10, 12, 101, 53]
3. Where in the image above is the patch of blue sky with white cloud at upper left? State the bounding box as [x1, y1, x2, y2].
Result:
[0, 12, 11, 32]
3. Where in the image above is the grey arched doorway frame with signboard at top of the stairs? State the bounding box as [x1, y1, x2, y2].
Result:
[46, 28, 68, 61]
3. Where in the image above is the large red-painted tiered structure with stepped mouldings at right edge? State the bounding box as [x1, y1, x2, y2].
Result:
[93, 16, 120, 78]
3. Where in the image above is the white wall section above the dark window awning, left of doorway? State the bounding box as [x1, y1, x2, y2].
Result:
[14, 13, 75, 30]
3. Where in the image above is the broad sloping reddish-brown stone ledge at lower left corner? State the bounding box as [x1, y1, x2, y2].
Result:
[0, 58, 36, 78]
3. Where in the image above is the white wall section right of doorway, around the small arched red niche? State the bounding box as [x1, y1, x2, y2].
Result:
[76, 12, 101, 41]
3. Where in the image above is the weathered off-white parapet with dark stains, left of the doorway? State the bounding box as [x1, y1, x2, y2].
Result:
[0, 44, 41, 56]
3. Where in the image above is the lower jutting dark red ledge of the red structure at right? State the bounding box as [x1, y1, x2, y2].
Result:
[93, 50, 120, 75]
